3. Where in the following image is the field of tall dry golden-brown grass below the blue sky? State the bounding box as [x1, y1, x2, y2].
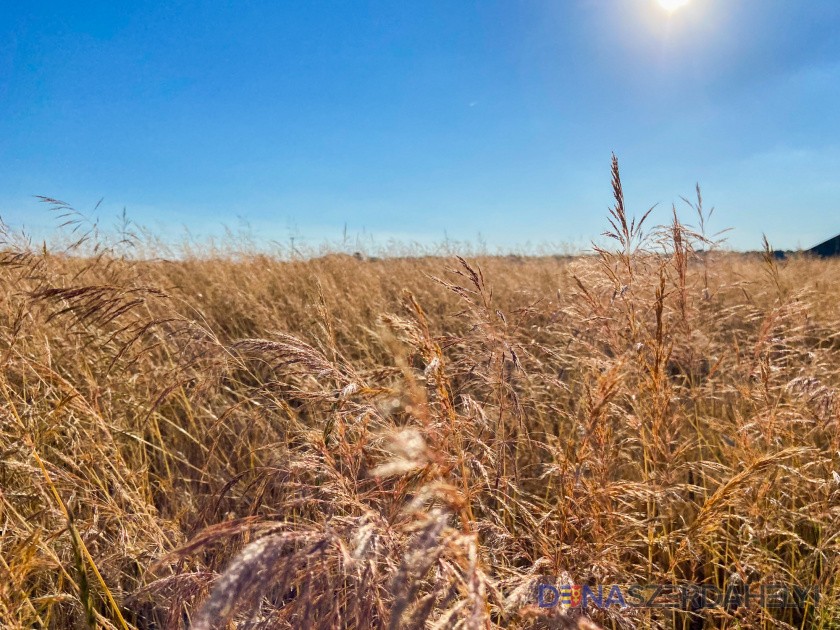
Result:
[0, 169, 840, 630]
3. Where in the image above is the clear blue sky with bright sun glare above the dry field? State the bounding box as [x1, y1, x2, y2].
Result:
[0, 0, 840, 249]
